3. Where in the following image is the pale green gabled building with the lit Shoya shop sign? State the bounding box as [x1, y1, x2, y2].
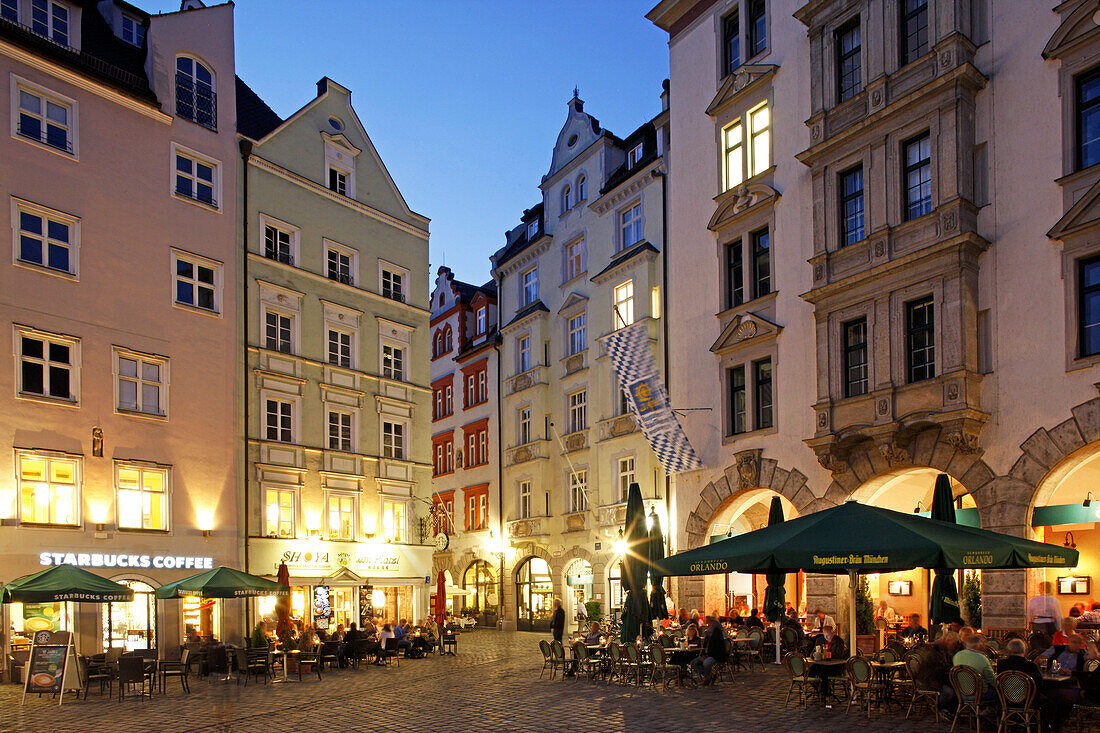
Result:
[237, 78, 431, 626]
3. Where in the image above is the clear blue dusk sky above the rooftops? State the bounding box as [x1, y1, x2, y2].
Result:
[141, 0, 669, 284]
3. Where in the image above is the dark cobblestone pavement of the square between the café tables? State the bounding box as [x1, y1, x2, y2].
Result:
[0, 631, 948, 733]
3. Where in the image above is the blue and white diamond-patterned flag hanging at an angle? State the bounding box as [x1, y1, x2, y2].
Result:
[603, 322, 703, 473]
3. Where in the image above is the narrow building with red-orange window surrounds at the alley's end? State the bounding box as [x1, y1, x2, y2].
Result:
[431, 266, 501, 627]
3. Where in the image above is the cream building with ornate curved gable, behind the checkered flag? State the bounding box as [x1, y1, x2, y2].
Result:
[493, 95, 669, 630]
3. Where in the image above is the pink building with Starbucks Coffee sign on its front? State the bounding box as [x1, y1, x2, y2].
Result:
[0, 0, 241, 654]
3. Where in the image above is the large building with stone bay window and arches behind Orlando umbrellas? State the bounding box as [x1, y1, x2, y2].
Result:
[648, 0, 1100, 627]
